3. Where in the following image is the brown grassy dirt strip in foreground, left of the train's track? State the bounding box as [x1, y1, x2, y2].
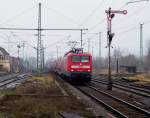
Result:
[0, 75, 94, 118]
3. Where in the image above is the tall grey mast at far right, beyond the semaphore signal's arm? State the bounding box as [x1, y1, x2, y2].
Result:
[140, 24, 143, 71]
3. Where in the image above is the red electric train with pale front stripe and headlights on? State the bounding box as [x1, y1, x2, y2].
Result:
[57, 49, 92, 82]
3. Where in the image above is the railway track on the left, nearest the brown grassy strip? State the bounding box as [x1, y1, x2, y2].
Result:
[0, 74, 27, 88]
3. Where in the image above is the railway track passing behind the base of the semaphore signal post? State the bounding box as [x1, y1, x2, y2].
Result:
[92, 79, 150, 98]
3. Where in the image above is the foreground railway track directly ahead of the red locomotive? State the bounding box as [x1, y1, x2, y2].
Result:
[76, 84, 150, 118]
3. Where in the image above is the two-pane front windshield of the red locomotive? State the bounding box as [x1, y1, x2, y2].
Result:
[72, 56, 90, 62]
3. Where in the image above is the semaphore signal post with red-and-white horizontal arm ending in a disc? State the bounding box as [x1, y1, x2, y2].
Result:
[105, 8, 127, 90]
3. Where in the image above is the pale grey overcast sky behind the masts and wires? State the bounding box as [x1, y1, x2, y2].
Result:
[0, 0, 150, 58]
